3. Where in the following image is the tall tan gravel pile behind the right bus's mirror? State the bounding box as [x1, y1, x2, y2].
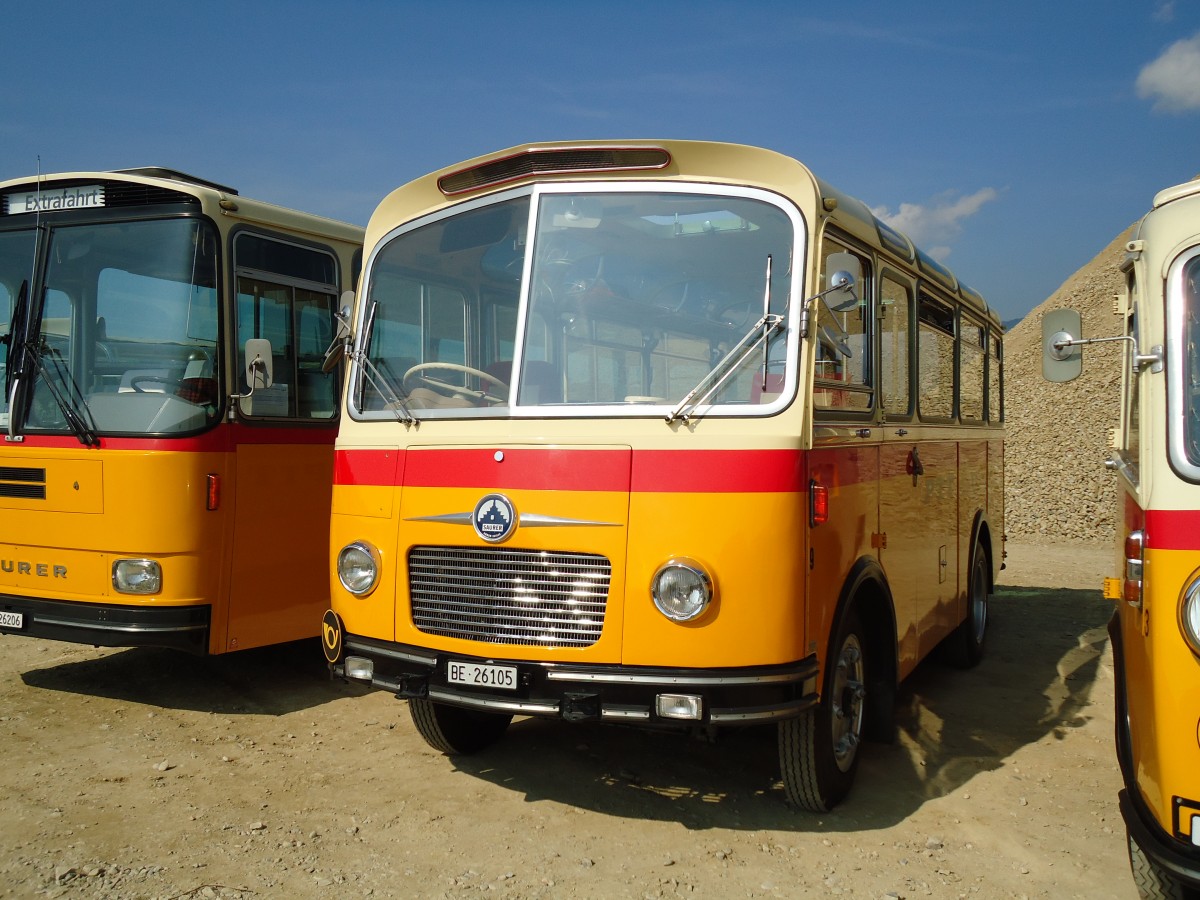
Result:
[1004, 226, 1134, 542]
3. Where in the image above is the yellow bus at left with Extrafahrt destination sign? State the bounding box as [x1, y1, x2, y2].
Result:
[0, 168, 362, 654]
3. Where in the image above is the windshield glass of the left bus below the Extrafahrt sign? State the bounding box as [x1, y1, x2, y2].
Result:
[0, 218, 222, 439]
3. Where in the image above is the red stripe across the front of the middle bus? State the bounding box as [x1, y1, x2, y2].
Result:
[334, 448, 804, 493]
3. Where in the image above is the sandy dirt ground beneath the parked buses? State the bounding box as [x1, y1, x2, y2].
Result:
[0, 545, 1136, 900]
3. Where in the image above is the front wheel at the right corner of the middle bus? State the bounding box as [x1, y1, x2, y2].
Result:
[779, 608, 869, 812]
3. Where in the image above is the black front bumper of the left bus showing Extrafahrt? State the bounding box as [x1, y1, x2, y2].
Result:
[0, 594, 211, 654]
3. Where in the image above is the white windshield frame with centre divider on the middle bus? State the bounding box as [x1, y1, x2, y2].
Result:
[346, 181, 810, 421]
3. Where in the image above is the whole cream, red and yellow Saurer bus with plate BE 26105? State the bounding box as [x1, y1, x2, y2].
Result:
[324, 142, 1003, 810]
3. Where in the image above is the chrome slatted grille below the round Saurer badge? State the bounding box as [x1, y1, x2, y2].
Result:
[408, 547, 612, 647]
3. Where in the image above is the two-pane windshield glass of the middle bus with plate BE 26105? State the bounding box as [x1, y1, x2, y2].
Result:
[352, 187, 798, 418]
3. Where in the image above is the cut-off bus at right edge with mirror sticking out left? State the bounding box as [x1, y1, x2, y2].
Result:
[1043, 180, 1200, 898]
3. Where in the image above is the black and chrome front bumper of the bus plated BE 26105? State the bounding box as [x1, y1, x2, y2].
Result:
[330, 634, 818, 727]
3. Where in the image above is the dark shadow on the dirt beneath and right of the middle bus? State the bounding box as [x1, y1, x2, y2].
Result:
[454, 588, 1111, 832]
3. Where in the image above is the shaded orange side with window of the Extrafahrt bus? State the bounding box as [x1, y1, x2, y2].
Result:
[224, 230, 340, 649]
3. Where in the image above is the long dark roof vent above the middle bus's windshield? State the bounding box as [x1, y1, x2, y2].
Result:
[438, 146, 671, 196]
